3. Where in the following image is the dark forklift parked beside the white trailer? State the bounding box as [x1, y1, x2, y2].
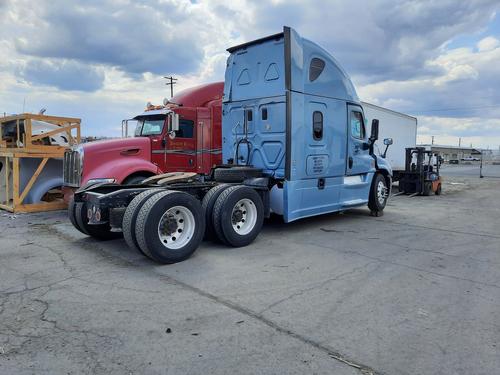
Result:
[398, 147, 441, 196]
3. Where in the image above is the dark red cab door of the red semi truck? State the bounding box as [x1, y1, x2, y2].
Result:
[165, 108, 197, 172]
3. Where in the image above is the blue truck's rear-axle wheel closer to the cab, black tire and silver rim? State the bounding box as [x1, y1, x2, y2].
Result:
[213, 185, 264, 247]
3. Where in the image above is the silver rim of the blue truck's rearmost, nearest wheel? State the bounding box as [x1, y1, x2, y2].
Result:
[158, 206, 196, 250]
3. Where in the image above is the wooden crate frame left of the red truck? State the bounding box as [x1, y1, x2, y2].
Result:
[0, 113, 80, 212]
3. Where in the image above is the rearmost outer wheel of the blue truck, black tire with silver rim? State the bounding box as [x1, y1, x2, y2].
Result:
[135, 190, 205, 264]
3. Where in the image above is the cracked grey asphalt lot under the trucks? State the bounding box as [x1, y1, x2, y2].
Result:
[0, 166, 500, 375]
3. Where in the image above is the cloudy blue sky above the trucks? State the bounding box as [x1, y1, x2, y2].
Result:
[0, 0, 500, 149]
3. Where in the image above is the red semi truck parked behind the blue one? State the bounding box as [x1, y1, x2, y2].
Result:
[64, 82, 224, 199]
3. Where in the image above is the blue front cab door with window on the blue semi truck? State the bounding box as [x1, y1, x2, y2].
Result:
[346, 104, 373, 176]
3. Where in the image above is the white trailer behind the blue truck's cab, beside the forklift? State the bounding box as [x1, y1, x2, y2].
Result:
[362, 102, 417, 180]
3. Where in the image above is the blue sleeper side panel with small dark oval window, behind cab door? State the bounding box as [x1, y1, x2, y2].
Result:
[283, 92, 346, 222]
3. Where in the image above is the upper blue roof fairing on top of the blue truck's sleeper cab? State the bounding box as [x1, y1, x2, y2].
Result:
[223, 26, 360, 103]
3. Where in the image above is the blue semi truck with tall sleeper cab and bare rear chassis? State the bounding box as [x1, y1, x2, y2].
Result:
[69, 27, 392, 263]
